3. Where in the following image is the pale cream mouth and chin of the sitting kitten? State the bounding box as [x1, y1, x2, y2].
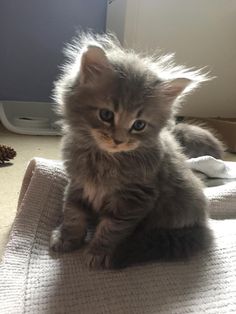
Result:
[92, 129, 138, 153]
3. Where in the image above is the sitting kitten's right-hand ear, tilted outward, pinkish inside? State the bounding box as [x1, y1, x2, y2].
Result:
[164, 78, 192, 99]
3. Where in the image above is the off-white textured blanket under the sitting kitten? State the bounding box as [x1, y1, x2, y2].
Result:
[0, 159, 236, 314]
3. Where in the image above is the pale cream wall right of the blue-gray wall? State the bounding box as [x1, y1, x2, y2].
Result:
[107, 0, 236, 117]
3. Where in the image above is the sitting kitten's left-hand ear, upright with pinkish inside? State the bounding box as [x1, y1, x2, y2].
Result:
[79, 46, 111, 84]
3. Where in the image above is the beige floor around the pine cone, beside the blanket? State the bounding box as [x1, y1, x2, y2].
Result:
[0, 124, 236, 257]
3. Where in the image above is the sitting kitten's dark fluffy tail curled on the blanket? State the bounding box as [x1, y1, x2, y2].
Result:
[112, 226, 213, 269]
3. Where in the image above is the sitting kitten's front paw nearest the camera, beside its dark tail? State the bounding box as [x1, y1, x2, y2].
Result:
[85, 249, 111, 269]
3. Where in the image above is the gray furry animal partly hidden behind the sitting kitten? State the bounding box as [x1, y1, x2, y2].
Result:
[173, 123, 224, 159]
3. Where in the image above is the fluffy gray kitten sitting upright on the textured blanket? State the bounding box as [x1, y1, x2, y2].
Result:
[50, 34, 211, 268]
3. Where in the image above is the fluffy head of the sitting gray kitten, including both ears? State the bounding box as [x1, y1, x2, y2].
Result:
[57, 33, 205, 153]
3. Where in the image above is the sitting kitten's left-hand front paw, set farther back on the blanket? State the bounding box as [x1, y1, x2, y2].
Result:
[49, 229, 81, 252]
